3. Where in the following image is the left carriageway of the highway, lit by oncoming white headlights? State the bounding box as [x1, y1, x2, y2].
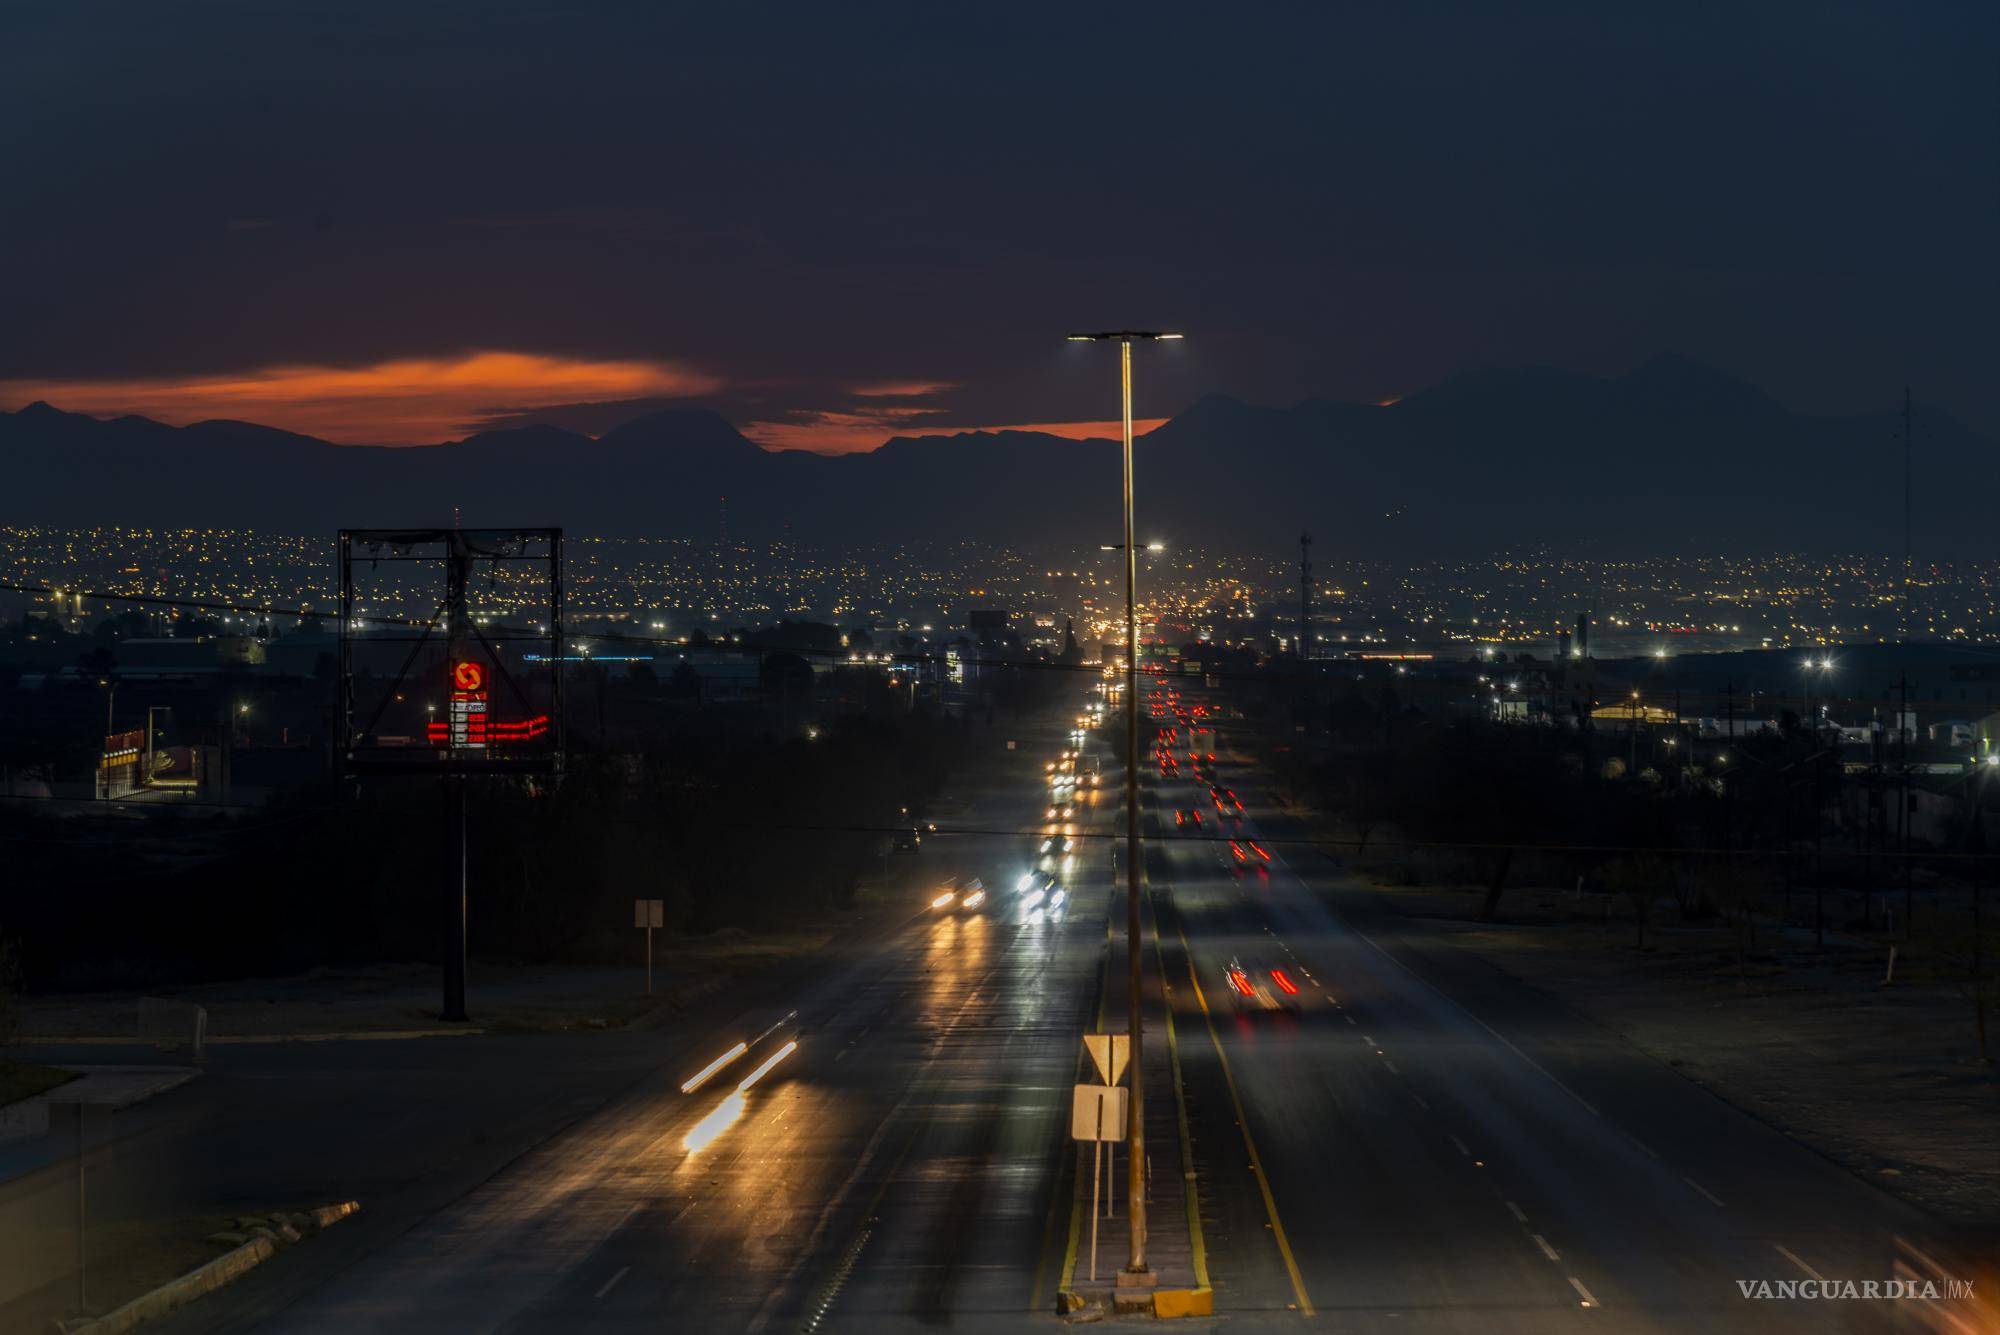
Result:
[225, 703, 1112, 1333]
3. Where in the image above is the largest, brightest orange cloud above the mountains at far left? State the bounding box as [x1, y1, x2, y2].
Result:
[0, 352, 722, 444]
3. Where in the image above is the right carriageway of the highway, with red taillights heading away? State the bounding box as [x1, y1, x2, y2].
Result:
[1152, 687, 1968, 1331]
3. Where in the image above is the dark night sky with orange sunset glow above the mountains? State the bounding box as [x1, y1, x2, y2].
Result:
[0, 0, 2000, 450]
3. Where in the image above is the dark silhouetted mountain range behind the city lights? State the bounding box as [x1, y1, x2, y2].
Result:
[0, 356, 2000, 560]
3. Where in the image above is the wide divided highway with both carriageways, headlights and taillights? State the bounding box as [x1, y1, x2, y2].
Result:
[121, 679, 1968, 1335]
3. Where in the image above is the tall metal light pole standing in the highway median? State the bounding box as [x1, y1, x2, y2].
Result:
[1070, 330, 1182, 1281]
